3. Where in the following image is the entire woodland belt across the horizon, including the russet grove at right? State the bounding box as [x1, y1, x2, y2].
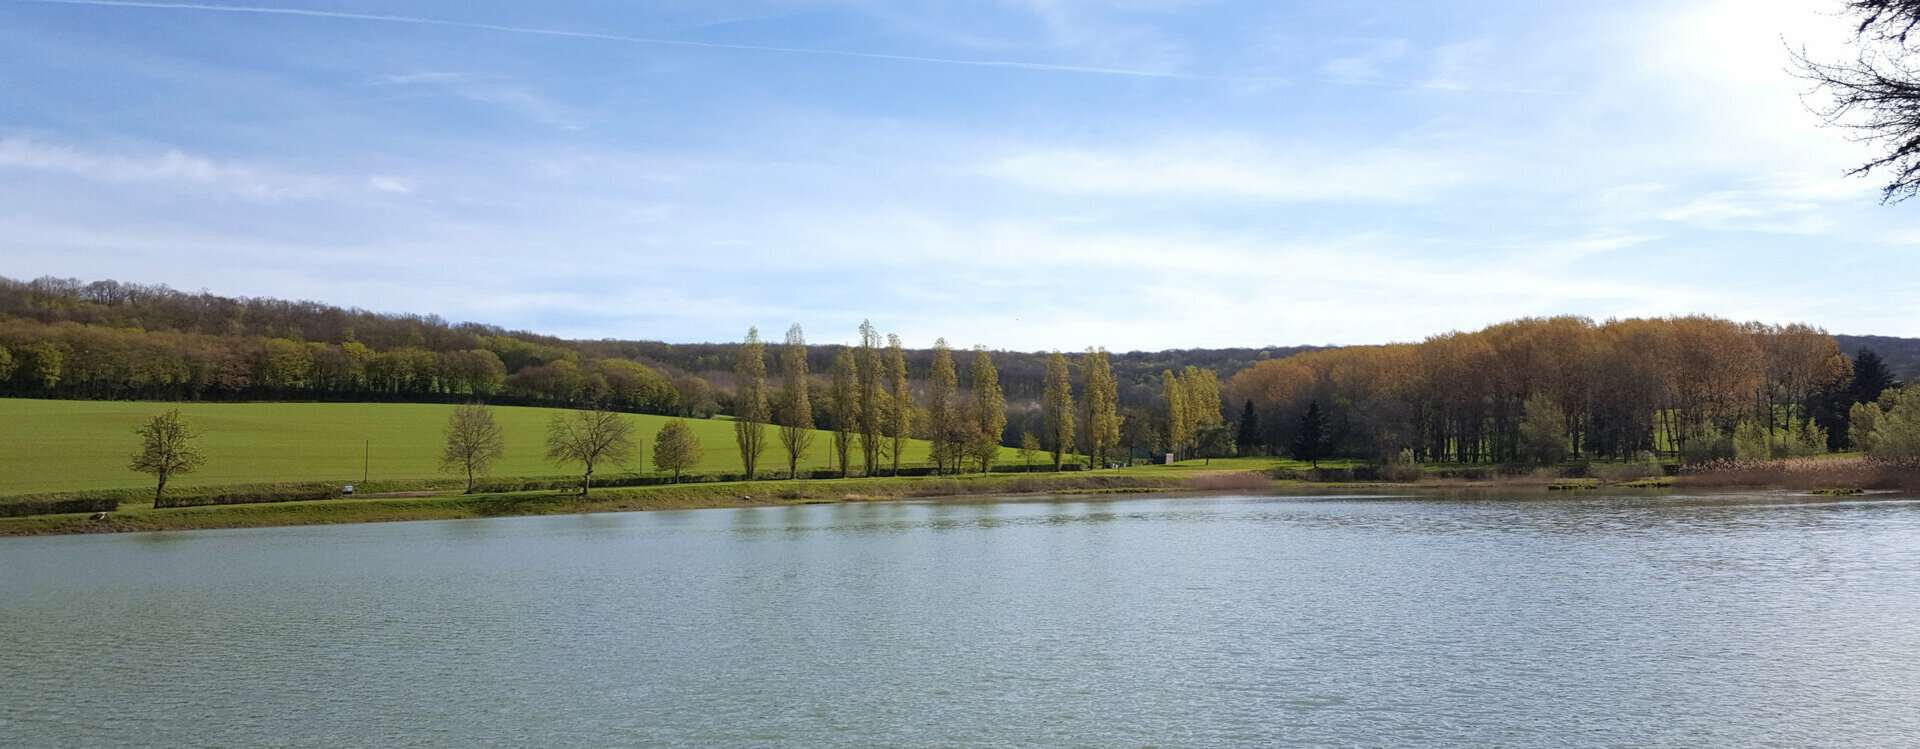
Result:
[0, 278, 1920, 463]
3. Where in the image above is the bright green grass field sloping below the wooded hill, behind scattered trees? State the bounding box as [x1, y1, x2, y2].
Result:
[0, 398, 990, 494]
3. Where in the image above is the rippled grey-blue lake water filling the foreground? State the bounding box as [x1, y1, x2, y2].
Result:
[0, 495, 1920, 747]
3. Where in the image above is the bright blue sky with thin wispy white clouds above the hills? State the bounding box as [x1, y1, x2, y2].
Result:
[0, 0, 1920, 351]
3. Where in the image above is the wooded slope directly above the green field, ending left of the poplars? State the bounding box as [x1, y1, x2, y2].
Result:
[0, 278, 720, 417]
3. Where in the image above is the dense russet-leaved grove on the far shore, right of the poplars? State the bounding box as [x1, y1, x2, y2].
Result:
[1225, 317, 1891, 463]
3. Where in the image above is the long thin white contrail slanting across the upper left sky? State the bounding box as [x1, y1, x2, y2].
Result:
[10, 0, 1244, 81]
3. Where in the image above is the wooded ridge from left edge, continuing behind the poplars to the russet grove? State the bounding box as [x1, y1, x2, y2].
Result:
[0, 277, 1282, 418]
